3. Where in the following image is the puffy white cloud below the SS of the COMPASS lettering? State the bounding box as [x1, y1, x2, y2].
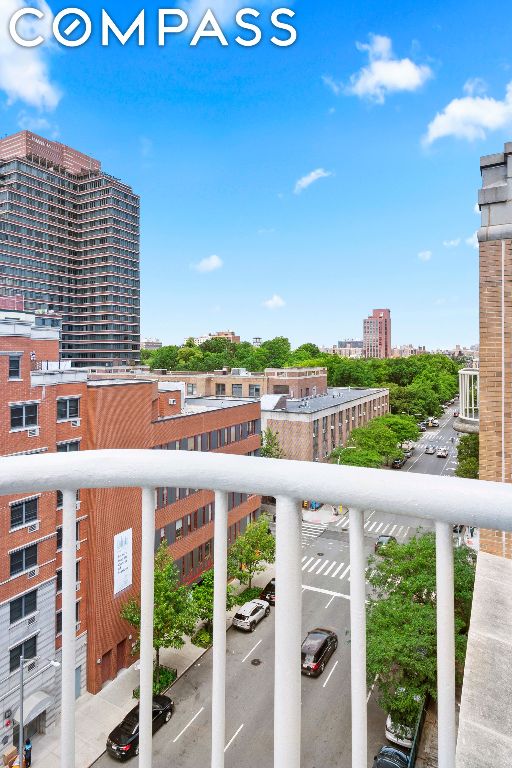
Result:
[344, 35, 433, 104]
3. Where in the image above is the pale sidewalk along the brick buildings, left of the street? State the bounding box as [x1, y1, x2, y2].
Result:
[32, 565, 275, 768]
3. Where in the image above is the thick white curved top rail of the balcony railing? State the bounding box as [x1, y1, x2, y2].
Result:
[0, 450, 512, 530]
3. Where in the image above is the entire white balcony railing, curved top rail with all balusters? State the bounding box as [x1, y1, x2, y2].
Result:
[0, 450, 512, 768]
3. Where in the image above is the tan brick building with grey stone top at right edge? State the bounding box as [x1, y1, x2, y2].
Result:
[478, 142, 512, 558]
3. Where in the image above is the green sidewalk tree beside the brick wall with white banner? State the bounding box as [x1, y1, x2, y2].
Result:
[121, 539, 197, 684]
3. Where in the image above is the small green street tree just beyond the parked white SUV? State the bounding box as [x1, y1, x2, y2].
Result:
[228, 515, 276, 588]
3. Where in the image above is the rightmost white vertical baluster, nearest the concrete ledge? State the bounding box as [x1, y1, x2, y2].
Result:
[436, 522, 455, 768]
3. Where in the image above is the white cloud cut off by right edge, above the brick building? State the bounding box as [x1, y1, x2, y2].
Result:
[423, 82, 512, 145]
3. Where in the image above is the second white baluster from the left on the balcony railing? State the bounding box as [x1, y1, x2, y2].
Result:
[139, 488, 155, 768]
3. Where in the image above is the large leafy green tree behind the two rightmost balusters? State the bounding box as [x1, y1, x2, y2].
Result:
[367, 533, 476, 727]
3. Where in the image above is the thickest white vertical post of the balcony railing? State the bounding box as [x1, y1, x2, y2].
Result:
[274, 497, 302, 768]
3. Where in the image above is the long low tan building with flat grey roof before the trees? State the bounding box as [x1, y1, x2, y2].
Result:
[261, 387, 389, 461]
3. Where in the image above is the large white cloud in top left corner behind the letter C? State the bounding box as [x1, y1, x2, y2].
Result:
[0, 0, 61, 111]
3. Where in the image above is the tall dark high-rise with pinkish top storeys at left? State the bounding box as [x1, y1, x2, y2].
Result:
[0, 131, 140, 367]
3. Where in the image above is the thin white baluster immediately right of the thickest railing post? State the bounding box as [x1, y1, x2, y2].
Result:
[349, 509, 367, 768]
